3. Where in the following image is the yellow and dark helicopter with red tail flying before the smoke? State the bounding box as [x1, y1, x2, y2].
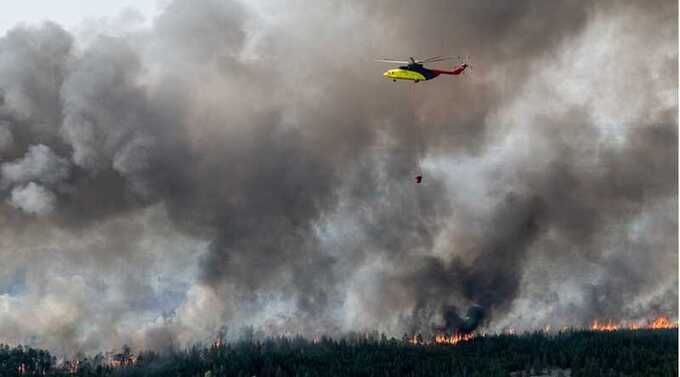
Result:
[376, 56, 470, 82]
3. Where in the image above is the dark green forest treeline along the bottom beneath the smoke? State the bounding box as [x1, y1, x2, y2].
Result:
[0, 329, 678, 377]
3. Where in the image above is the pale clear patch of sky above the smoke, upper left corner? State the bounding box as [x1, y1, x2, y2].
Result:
[0, 0, 165, 34]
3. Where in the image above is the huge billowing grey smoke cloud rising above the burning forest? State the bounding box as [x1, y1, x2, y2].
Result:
[0, 0, 678, 353]
